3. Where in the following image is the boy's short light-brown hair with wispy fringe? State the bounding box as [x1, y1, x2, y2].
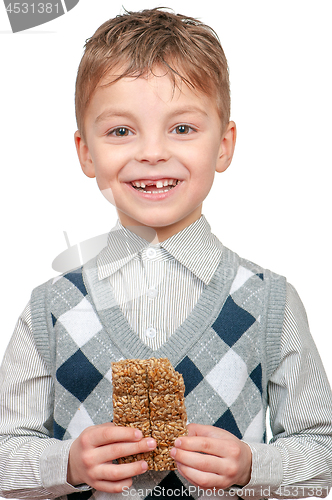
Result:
[75, 9, 230, 137]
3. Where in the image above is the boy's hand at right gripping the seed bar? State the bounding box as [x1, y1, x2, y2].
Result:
[171, 424, 252, 489]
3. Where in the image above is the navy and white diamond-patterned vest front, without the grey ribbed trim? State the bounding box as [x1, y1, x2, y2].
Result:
[47, 262, 265, 500]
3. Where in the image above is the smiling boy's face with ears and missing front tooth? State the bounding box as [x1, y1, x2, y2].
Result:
[75, 68, 235, 241]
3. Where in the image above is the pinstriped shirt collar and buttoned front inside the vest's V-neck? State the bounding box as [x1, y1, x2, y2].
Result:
[97, 216, 222, 350]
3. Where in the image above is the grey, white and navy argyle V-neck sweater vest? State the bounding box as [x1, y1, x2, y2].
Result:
[31, 247, 286, 500]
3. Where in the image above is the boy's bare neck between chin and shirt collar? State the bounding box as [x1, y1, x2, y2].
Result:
[118, 206, 202, 245]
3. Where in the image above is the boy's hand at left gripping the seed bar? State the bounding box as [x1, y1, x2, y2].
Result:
[67, 423, 156, 493]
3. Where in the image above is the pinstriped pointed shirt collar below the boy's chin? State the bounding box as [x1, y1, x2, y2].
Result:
[97, 215, 222, 284]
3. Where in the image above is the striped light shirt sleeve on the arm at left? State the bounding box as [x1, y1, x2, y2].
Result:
[0, 304, 80, 499]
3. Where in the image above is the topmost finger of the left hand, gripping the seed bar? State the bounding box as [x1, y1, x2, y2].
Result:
[82, 423, 143, 447]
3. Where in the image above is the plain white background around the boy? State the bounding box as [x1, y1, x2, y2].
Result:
[0, 0, 332, 496]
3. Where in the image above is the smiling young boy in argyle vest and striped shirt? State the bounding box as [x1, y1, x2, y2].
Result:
[0, 9, 332, 499]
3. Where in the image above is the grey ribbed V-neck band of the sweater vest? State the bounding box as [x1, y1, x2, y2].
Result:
[83, 247, 238, 366]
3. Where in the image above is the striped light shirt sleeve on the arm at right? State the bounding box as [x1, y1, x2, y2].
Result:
[244, 284, 332, 498]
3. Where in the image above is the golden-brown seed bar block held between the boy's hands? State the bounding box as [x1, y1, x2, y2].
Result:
[112, 358, 187, 471]
